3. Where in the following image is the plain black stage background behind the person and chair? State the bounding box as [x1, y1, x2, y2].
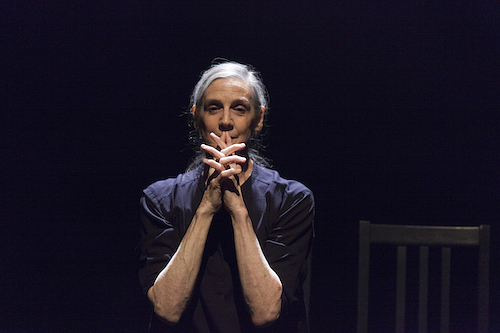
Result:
[0, 1, 500, 332]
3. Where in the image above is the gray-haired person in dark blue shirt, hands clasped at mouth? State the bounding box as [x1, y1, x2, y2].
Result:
[139, 61, 314, 333]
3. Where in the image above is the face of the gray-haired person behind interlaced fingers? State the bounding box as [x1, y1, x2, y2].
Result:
[198, 78, 264, 147]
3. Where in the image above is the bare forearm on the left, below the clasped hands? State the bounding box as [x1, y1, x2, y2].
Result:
[148, 209, 213, 323]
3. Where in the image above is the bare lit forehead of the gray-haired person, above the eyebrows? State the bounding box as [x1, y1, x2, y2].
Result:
[204, 77, 253, 100]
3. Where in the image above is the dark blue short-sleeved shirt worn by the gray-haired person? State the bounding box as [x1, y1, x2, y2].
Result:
[139, 164, 314, 333]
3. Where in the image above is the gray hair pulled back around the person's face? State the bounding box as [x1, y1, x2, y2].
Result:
[187, 61, 271, 171]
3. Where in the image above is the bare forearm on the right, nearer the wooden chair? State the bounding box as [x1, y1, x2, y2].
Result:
[233, 213, 282, 326]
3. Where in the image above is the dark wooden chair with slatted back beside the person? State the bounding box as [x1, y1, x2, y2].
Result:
[357, 221, 490, 333]
